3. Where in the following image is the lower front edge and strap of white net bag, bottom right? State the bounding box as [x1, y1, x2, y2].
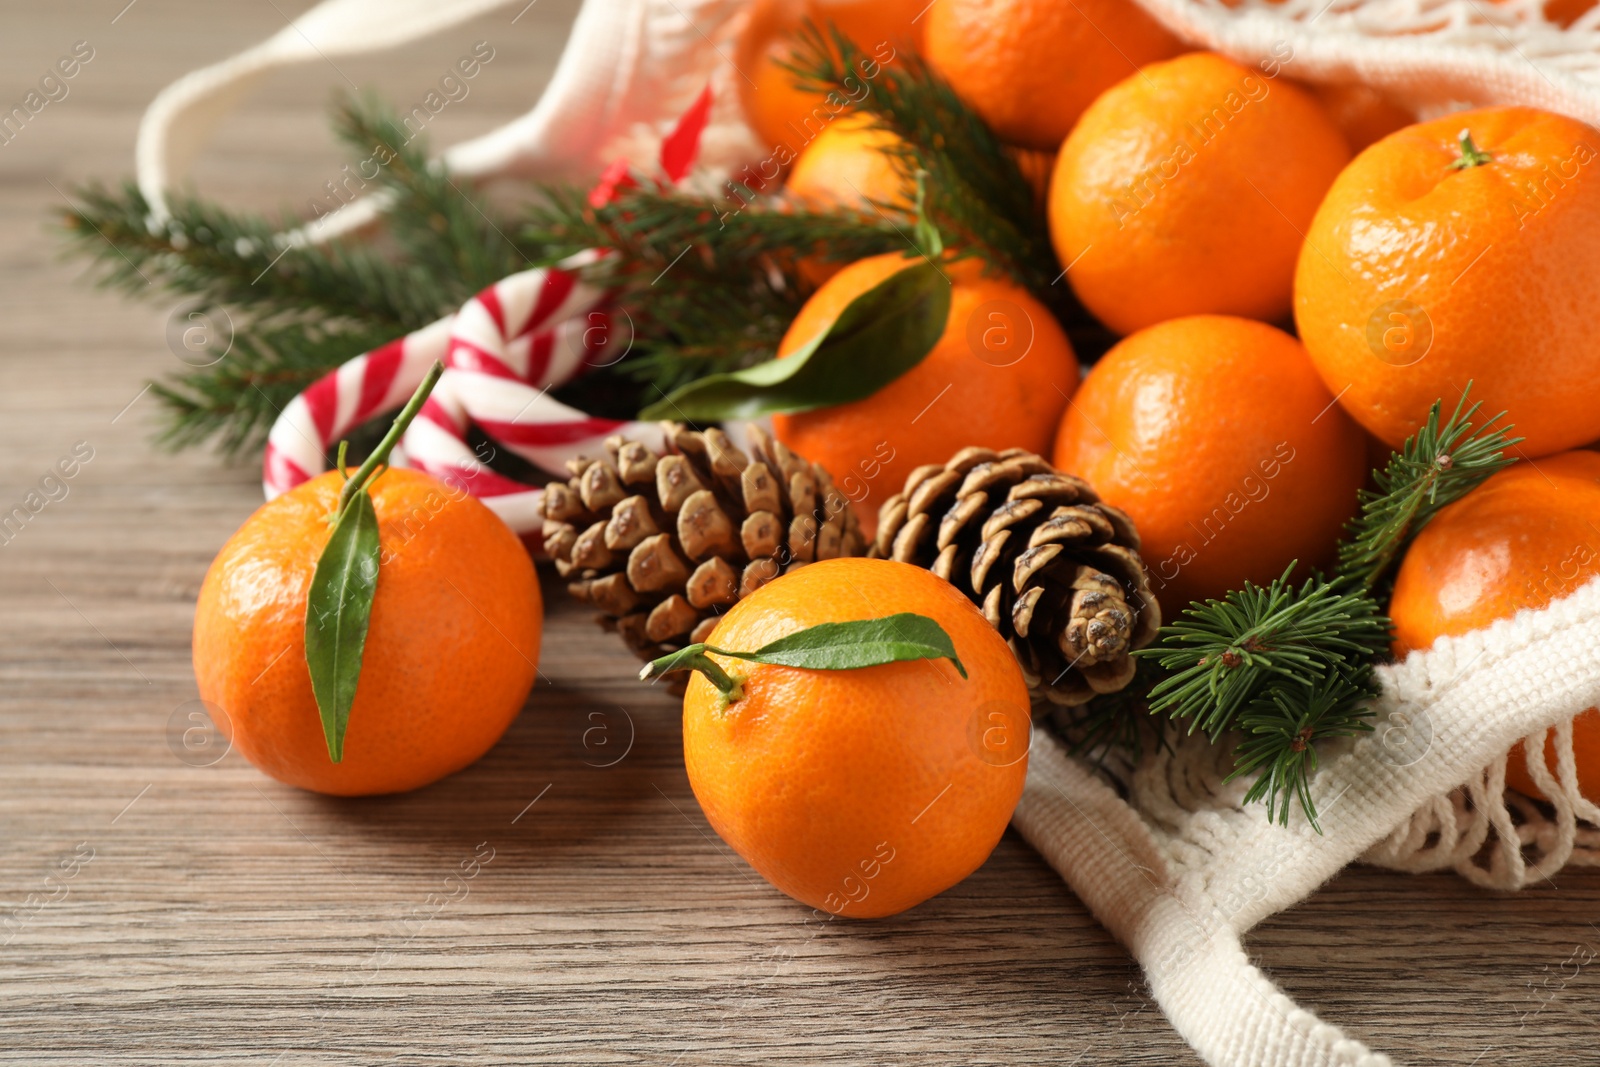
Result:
[1014, 581, 1600, 1067]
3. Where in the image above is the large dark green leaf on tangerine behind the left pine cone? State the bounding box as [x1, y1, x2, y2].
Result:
[638, 261, 950, 422]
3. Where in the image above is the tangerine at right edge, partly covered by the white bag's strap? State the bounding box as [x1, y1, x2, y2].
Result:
[1389, 451, 1600, 801]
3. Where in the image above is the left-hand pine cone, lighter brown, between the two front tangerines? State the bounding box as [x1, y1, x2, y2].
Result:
[541, 422, 866, 659]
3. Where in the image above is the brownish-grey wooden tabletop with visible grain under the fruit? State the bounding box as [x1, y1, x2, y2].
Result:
[0, 0, 1600, 1067]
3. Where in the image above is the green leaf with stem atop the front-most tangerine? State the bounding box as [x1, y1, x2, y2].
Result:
[638, 611, 966, 701]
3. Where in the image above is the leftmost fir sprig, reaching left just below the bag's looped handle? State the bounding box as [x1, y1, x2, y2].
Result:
[62, 181, 451, 333]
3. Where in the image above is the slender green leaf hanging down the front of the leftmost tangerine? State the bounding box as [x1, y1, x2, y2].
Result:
[306, 493, 379, 763]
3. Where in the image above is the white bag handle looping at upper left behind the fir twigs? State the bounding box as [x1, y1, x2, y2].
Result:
[134, 0, 754, 242]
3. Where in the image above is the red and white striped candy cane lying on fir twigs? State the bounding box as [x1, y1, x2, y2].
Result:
[262, 267, 661, 534]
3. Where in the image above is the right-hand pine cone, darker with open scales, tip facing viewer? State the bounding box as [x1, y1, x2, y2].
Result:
[872, 448, 1162, 705]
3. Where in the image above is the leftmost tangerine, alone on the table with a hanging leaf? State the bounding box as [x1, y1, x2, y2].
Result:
[194, 469, 542, 797]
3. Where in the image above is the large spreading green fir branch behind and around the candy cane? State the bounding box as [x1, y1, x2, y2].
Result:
[64, 89, 904, 456]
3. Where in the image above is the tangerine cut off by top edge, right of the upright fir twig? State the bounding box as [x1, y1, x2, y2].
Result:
[923, 0, 1184, 152]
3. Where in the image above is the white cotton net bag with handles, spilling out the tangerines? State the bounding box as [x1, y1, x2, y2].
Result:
[138, 0, 1600, 1067]
